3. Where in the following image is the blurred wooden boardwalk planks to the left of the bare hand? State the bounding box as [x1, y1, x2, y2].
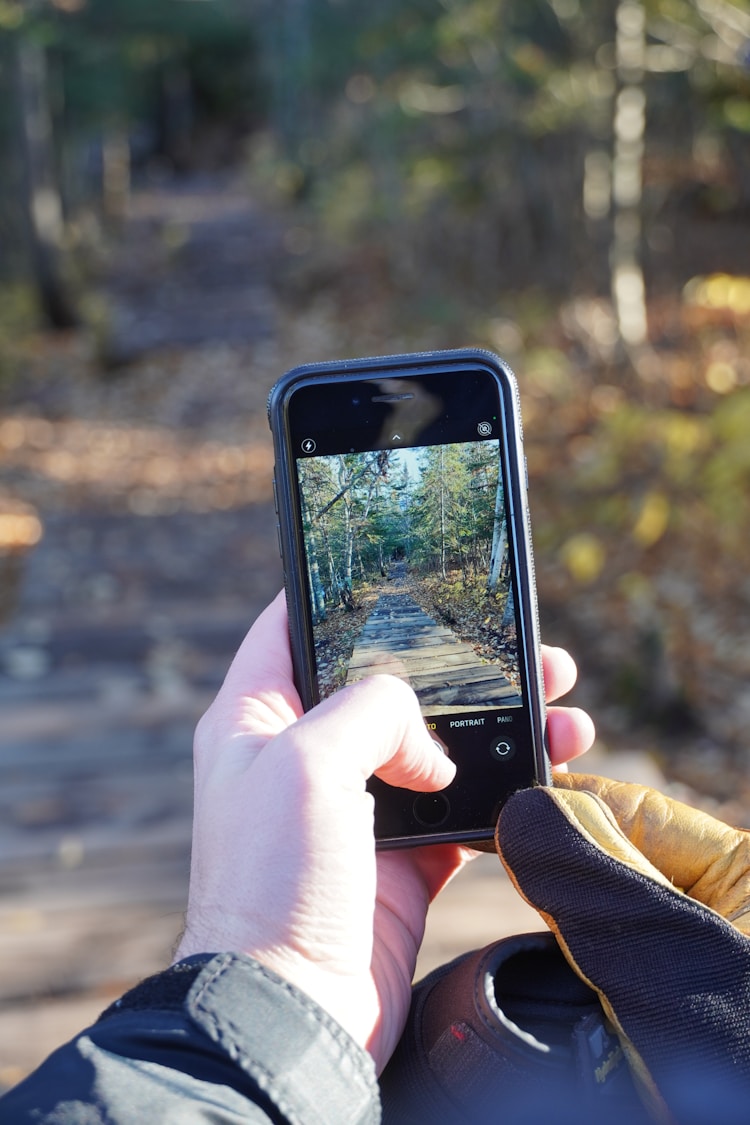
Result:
[0, 503, 281, 1089]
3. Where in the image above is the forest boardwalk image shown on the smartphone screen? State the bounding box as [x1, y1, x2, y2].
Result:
[297, 440, 522, 714]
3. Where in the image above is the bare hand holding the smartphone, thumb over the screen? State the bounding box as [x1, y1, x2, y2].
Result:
[175, 595, 593, 1068]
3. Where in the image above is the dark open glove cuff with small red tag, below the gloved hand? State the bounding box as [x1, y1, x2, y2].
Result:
[381, 933, 648, 1125]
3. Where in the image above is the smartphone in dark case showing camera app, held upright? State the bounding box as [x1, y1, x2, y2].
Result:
[269, 350, 550, 847]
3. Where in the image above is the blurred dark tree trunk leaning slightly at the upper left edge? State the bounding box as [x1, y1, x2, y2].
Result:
[13, 35, 79, 330]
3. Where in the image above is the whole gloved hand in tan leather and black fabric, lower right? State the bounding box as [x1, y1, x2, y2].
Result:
[497, 774, 750, 1125]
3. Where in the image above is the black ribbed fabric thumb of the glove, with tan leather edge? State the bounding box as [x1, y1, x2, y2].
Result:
[496, 788, 750, 1121]
